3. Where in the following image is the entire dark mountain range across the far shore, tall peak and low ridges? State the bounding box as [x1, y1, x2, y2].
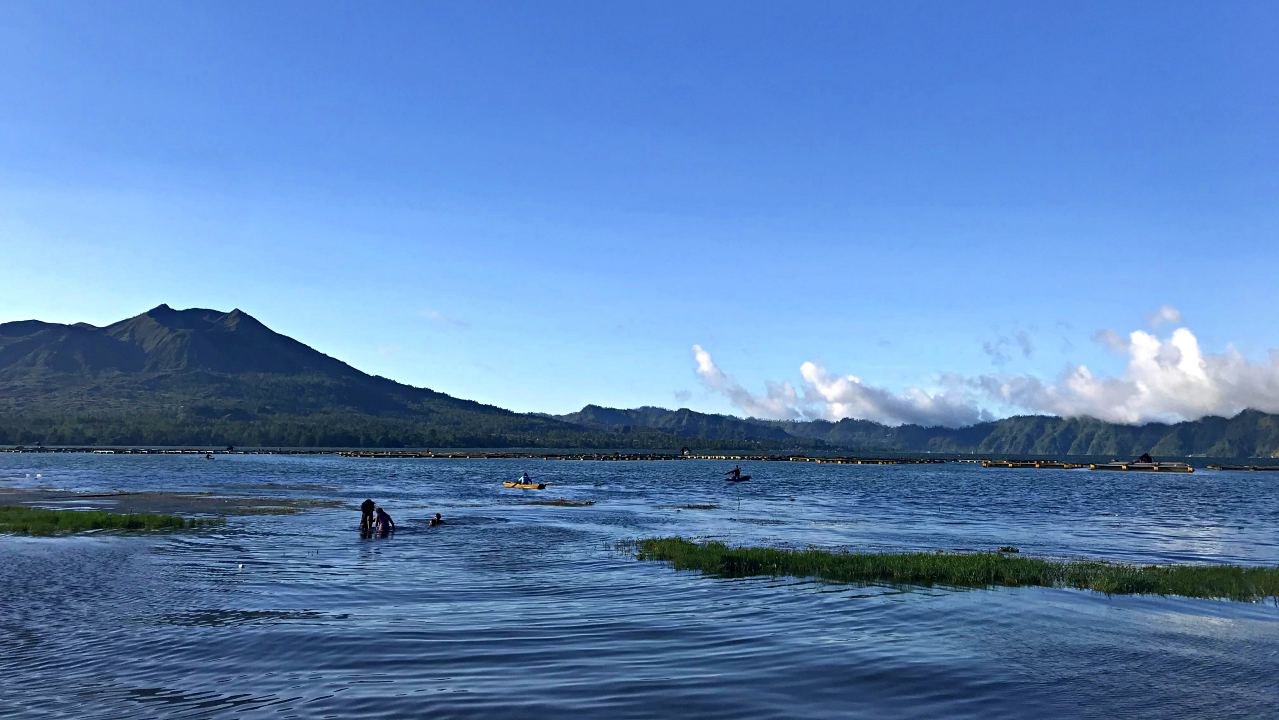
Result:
[0, 304, 1279, 457]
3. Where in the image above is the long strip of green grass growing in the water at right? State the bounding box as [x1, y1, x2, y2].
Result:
[636, 537, 1279, 602]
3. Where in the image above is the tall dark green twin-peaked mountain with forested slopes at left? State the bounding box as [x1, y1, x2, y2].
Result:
[0, 304, 649, 446]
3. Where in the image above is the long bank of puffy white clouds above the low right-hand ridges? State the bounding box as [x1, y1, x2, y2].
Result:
[693, 317, 1279, 427]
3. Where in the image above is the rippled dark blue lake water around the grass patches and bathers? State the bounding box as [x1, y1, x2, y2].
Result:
[0, 455, 1279, 717]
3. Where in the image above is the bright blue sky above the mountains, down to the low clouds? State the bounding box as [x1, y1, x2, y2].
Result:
[0, 1, 1279, 423]
